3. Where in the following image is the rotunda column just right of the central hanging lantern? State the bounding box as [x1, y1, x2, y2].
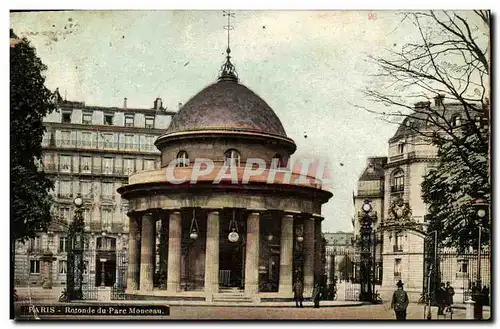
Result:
[245, 213, 260, 296]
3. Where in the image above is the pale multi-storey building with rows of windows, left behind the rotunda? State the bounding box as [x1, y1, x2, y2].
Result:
[14, 90, 173, 288]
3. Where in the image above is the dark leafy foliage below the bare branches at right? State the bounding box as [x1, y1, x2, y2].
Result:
[422, 121, 491, 251]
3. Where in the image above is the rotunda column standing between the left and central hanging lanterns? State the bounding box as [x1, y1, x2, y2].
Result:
[205, 211, 219, 301]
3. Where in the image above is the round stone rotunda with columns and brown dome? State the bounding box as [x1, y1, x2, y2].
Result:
[118, 56, 332, 303]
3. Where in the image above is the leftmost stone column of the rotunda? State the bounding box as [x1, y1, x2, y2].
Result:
[127, 216, 141, 290]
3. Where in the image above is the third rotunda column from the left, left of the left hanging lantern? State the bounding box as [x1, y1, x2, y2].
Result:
[167, 212, 182, 292]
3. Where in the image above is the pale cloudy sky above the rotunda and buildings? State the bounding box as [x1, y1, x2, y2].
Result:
[10, 11, 484, 232]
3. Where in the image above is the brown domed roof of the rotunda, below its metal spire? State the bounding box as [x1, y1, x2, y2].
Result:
[165, 79, 286, 137]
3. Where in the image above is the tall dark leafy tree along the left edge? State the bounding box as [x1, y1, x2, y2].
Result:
[10, 30, 55, 243]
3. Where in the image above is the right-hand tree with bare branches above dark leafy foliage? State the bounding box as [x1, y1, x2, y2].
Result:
[365, 11, 491, 248]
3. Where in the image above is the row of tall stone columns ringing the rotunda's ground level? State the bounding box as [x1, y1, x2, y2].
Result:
[127, 210, 321, 299]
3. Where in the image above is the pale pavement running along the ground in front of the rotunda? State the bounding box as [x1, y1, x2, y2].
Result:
[14, 304, 489, 320]
